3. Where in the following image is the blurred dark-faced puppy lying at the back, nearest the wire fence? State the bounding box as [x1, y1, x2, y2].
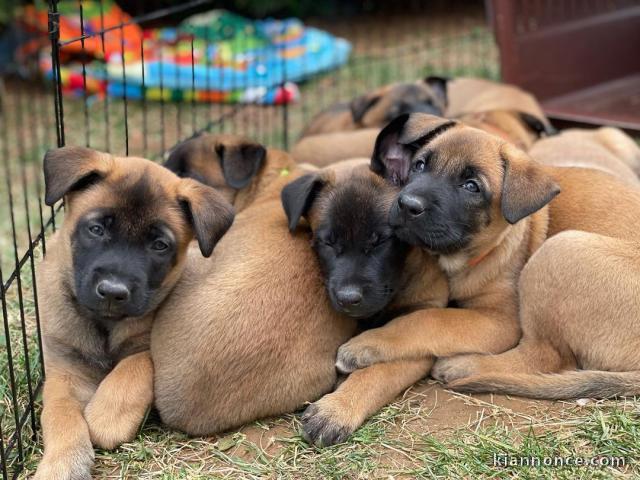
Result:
[302, 77, 446, 137]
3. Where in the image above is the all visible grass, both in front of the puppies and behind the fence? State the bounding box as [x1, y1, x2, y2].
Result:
[0, 13, 640, 480]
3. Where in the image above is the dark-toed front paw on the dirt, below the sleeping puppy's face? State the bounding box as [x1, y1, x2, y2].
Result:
[301, 394, 361, 447]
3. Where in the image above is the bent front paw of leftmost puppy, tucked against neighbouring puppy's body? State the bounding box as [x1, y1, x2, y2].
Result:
[84, 401, 145, 450]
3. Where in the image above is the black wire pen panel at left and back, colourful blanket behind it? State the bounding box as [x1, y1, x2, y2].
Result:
[0, 0, 498, 478]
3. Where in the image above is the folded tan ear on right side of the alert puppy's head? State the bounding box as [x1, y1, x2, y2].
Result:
[500, 143, 560, 224]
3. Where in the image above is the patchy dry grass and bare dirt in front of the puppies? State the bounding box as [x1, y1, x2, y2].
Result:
[20, 381, 640, 479]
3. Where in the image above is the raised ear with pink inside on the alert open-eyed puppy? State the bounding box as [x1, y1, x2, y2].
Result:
[371, 113, 456, 185]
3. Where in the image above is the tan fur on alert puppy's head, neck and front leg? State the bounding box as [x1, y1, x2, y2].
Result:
[337, 118, 552, 372]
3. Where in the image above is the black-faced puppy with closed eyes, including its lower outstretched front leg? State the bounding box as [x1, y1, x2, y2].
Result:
[282, 164, 448, 445]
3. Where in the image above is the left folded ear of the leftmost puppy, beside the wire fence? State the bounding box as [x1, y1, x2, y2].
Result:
[43, 147, 112, 206]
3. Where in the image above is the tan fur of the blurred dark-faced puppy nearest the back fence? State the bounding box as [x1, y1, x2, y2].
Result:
[302, 80, 445, 137]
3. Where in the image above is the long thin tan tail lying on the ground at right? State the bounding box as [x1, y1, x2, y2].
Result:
[447, 370, 640, 400]
